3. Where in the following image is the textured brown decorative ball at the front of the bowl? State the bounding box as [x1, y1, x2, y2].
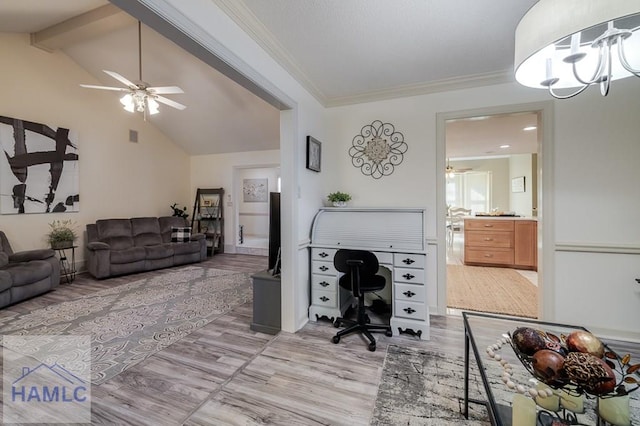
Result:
[564, 352, 616, 395]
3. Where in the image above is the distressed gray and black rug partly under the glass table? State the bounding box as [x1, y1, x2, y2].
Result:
[371, 345, 490, 426]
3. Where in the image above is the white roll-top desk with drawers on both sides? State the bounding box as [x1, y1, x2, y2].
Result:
[309, 208, 429, 340]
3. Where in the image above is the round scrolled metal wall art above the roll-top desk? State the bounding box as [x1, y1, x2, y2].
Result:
[349, 120, 408, 179]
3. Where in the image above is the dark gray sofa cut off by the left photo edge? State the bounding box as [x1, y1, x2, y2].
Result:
[0, 231, 60, 308]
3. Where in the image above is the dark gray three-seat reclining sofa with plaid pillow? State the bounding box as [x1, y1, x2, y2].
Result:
[87, 216, 207, 279]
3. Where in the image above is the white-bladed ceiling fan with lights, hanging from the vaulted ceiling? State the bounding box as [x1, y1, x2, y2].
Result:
[80, 21, 186, 116]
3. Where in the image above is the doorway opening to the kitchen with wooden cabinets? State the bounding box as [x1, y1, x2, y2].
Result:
[439, 108, 543, 317]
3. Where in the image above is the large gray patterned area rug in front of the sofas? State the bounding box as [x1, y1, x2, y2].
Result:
[0, 266, 252, 384]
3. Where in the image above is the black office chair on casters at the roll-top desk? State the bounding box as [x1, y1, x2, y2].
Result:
[332, 250, 392, 352]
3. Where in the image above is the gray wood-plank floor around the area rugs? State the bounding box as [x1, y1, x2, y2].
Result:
[3, 254, 636, 425]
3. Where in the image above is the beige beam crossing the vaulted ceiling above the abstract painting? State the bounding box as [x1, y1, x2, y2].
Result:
[31, 4, 136, 52]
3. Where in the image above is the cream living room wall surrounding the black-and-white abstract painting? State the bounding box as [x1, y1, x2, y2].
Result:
[0, 33, 189, 267]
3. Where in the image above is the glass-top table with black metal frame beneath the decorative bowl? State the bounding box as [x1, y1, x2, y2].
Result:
[462, 311, 640, 426]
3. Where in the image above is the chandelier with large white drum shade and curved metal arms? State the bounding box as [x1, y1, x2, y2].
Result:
[515, 0, 640, 99]
